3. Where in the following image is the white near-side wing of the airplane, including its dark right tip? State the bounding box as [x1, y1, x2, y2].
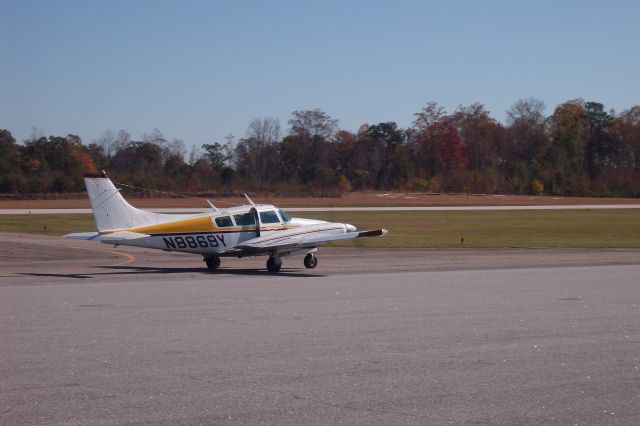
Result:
[237, 224, 387, 253]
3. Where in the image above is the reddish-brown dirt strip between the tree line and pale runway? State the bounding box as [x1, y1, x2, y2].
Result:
[0, 192, 640, 209]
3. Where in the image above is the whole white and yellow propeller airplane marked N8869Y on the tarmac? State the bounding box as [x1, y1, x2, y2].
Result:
[64, 172, 387, 272]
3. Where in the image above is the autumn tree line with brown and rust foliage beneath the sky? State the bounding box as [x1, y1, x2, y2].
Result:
[0, 98, 640, 197]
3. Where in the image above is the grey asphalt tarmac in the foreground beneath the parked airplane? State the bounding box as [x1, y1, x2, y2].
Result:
[0, 234, 640, 425]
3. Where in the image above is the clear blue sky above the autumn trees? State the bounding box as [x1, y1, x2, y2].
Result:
[0, 0, 640, 147]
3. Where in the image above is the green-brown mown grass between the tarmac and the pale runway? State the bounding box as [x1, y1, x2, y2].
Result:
[0, 209, 640, 248]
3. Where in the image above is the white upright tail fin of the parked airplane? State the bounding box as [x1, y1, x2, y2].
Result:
[84, 172, 166, 231]
